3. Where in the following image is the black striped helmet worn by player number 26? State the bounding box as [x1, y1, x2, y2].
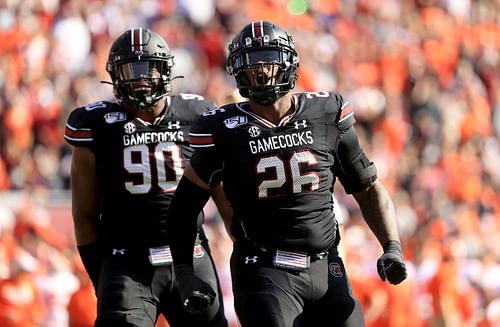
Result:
[226, 21, 299, 104]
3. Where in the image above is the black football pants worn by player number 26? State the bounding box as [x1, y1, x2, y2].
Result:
[231, 242, 364, 327]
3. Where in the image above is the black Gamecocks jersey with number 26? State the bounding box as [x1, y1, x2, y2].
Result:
[189, 92, 364, 251]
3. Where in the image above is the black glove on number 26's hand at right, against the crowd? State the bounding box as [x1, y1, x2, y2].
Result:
[377, 241, 408, 285]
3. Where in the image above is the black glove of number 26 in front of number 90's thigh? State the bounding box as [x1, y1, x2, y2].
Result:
[174, 264, 216, 314]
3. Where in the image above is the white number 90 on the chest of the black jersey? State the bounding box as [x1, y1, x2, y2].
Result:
[123, 142, 184, 194]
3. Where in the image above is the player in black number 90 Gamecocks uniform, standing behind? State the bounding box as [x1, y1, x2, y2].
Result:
[64, 28, 227, 327]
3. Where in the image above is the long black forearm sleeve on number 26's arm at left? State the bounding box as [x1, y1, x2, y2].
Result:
[167, 177, 210, 267]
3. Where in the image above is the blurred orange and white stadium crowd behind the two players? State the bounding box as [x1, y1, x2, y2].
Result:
[0, 0, 500, 327]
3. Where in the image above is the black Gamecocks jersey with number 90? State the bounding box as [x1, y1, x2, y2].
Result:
[64, 94, 215, 251]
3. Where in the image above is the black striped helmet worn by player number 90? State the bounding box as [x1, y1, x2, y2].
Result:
[106, 28, 174, 111]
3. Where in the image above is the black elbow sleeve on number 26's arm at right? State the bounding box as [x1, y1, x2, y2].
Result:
[334, 126, 377, 194]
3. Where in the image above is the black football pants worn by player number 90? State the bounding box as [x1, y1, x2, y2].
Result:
[95, 245, 227, 327]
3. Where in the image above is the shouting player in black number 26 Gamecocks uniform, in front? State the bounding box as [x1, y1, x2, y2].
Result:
[168, 21, 407, 327]
